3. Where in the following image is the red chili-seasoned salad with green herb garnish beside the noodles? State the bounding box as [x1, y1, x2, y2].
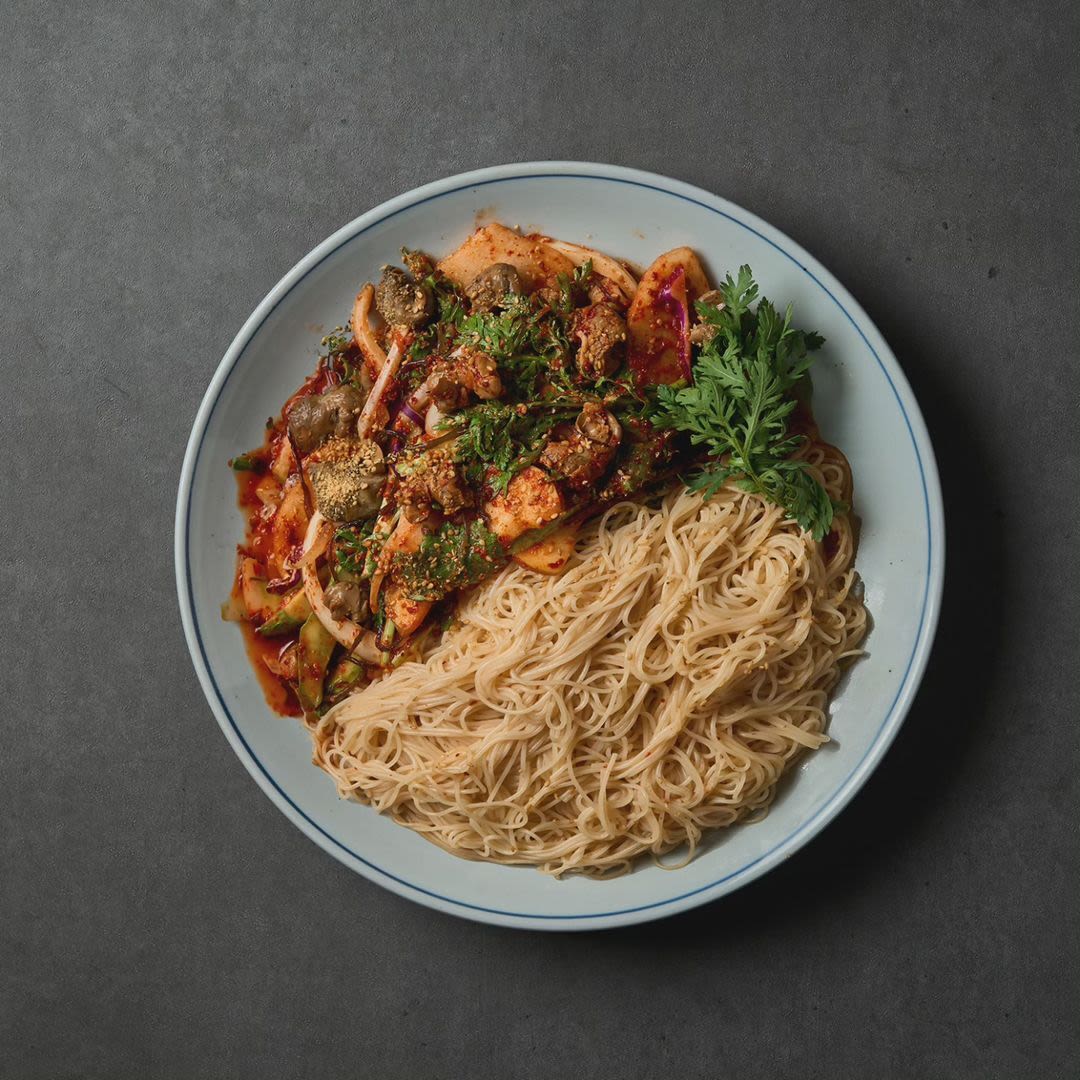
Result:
[222, 225, 850, 716]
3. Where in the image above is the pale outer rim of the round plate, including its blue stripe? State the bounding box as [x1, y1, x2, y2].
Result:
[174, 161, 945, 930]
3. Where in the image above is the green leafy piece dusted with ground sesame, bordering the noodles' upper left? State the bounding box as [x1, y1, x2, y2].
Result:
[394, 518, 507, 600]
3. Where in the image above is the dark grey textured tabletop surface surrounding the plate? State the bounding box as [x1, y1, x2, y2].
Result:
[0, 0, 1080, 1080]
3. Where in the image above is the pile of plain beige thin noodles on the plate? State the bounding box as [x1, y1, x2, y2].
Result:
[313, 444, 866, 876]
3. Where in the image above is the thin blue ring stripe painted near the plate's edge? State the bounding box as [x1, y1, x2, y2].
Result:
[184, 172, 933, 921]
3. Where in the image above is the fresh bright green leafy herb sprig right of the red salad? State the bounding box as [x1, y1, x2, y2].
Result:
[650, 266, 838, 540]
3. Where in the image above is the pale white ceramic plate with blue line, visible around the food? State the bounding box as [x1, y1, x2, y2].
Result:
[176, 162, 944, 930]
